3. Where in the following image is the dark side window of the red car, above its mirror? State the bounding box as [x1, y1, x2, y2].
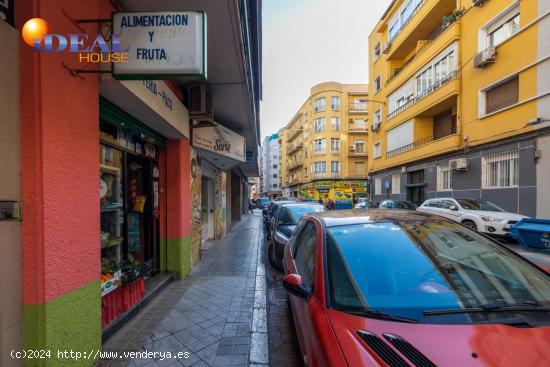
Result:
[294, 222, 317, 289]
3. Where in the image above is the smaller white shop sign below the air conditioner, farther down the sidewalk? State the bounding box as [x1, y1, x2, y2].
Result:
[193, 122, 245, 162]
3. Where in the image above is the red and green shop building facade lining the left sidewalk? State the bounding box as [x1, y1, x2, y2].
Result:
[0, 0, 261, 366]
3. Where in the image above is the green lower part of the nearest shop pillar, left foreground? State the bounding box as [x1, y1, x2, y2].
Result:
[23, 280, 101, 367]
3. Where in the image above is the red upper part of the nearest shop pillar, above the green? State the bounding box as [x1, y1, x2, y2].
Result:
[16, 0, 115, 304]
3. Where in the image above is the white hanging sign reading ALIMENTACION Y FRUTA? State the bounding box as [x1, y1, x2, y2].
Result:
[112, 11, 206, 80]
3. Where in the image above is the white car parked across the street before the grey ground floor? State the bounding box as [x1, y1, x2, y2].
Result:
[416, 198, 527, 236]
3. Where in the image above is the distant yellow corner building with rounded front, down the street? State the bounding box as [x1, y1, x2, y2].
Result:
[279, 82, 369, 207]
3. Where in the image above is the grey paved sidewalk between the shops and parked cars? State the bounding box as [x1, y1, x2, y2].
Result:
[99, 211, 268, 367]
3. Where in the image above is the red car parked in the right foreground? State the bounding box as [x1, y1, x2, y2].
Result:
[283, 210, 550, 367]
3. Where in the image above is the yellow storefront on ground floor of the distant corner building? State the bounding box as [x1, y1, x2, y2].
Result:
[299, 180, 367, 209]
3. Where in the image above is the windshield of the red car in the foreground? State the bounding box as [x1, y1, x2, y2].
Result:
[327, 220, 550, 323]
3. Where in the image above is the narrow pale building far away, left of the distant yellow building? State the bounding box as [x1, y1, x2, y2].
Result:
[262, 134, 282, 199]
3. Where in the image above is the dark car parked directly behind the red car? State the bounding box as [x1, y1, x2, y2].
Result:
[268, 203, 325, 269]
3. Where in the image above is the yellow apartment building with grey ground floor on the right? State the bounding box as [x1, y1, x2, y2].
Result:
[368, 0, 550, 217]
